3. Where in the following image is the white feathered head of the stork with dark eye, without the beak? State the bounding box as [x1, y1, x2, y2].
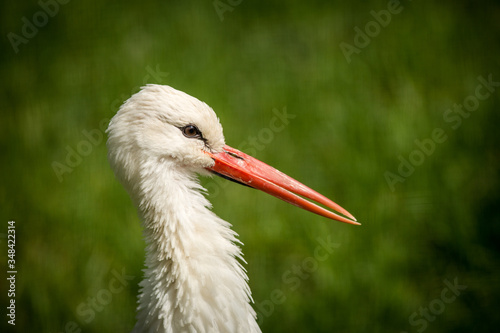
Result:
[107, 84, 224, 178]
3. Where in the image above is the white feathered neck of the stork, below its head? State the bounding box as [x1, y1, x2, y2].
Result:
[131, 162, 260, 332]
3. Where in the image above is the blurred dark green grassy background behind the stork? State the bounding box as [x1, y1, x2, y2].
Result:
[0, 0, 500, 332]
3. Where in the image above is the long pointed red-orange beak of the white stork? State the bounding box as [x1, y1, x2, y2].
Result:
[207, 145, 360, 225]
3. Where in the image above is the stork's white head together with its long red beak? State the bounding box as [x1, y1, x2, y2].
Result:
[107, 84, 359, 224]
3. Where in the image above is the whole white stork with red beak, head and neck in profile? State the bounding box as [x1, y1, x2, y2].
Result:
[107, 84, 359, 333]
